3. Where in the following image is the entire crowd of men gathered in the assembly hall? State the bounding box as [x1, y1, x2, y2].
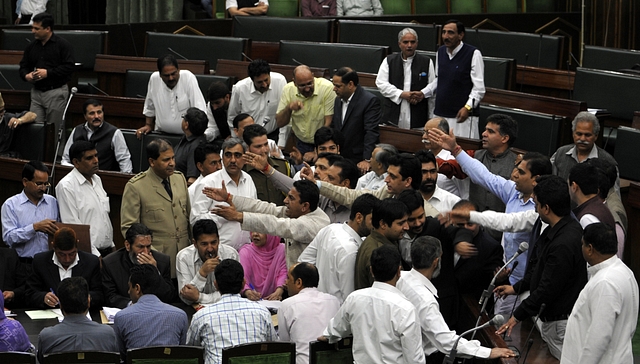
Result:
[0, 14, 639, 364]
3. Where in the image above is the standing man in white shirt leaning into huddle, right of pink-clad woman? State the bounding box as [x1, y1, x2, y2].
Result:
[298, 193, 379, 303]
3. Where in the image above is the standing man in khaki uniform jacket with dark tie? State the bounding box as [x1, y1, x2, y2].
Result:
[120, 139, 191, 278]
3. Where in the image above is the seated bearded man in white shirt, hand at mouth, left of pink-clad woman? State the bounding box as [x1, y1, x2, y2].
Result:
[176, 220, 239, 305]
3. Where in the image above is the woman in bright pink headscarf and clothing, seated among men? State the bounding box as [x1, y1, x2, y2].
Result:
[238, 232, 287, 301]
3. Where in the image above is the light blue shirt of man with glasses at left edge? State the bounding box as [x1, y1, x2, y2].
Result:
[2, 191, 60, 258]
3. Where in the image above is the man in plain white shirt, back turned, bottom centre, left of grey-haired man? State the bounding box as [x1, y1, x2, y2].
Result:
[318, 245, 425, 364]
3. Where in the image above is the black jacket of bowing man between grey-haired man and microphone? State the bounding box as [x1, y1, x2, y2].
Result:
[455, 230, 504, 300]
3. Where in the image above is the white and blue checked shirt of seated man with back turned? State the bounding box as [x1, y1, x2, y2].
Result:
[187, 294, 277, 364]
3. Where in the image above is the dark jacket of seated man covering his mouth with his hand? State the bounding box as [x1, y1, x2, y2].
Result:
[102, 248, 177, 308]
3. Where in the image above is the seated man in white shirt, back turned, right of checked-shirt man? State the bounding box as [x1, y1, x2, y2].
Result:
[278, 263, 340, 364]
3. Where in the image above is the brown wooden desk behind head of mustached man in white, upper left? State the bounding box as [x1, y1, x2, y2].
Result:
[93, 54, 210, 96]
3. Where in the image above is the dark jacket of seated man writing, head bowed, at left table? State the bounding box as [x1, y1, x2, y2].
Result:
[27, 250, 104, 309]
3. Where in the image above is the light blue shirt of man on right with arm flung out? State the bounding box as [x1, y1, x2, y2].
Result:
[456, 151, 535, 284]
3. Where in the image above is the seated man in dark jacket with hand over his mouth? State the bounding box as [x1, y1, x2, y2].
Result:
[102, 223, 176, 308]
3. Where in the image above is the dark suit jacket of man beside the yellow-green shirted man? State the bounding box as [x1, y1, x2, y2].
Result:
[331, 86, 382, 163]
